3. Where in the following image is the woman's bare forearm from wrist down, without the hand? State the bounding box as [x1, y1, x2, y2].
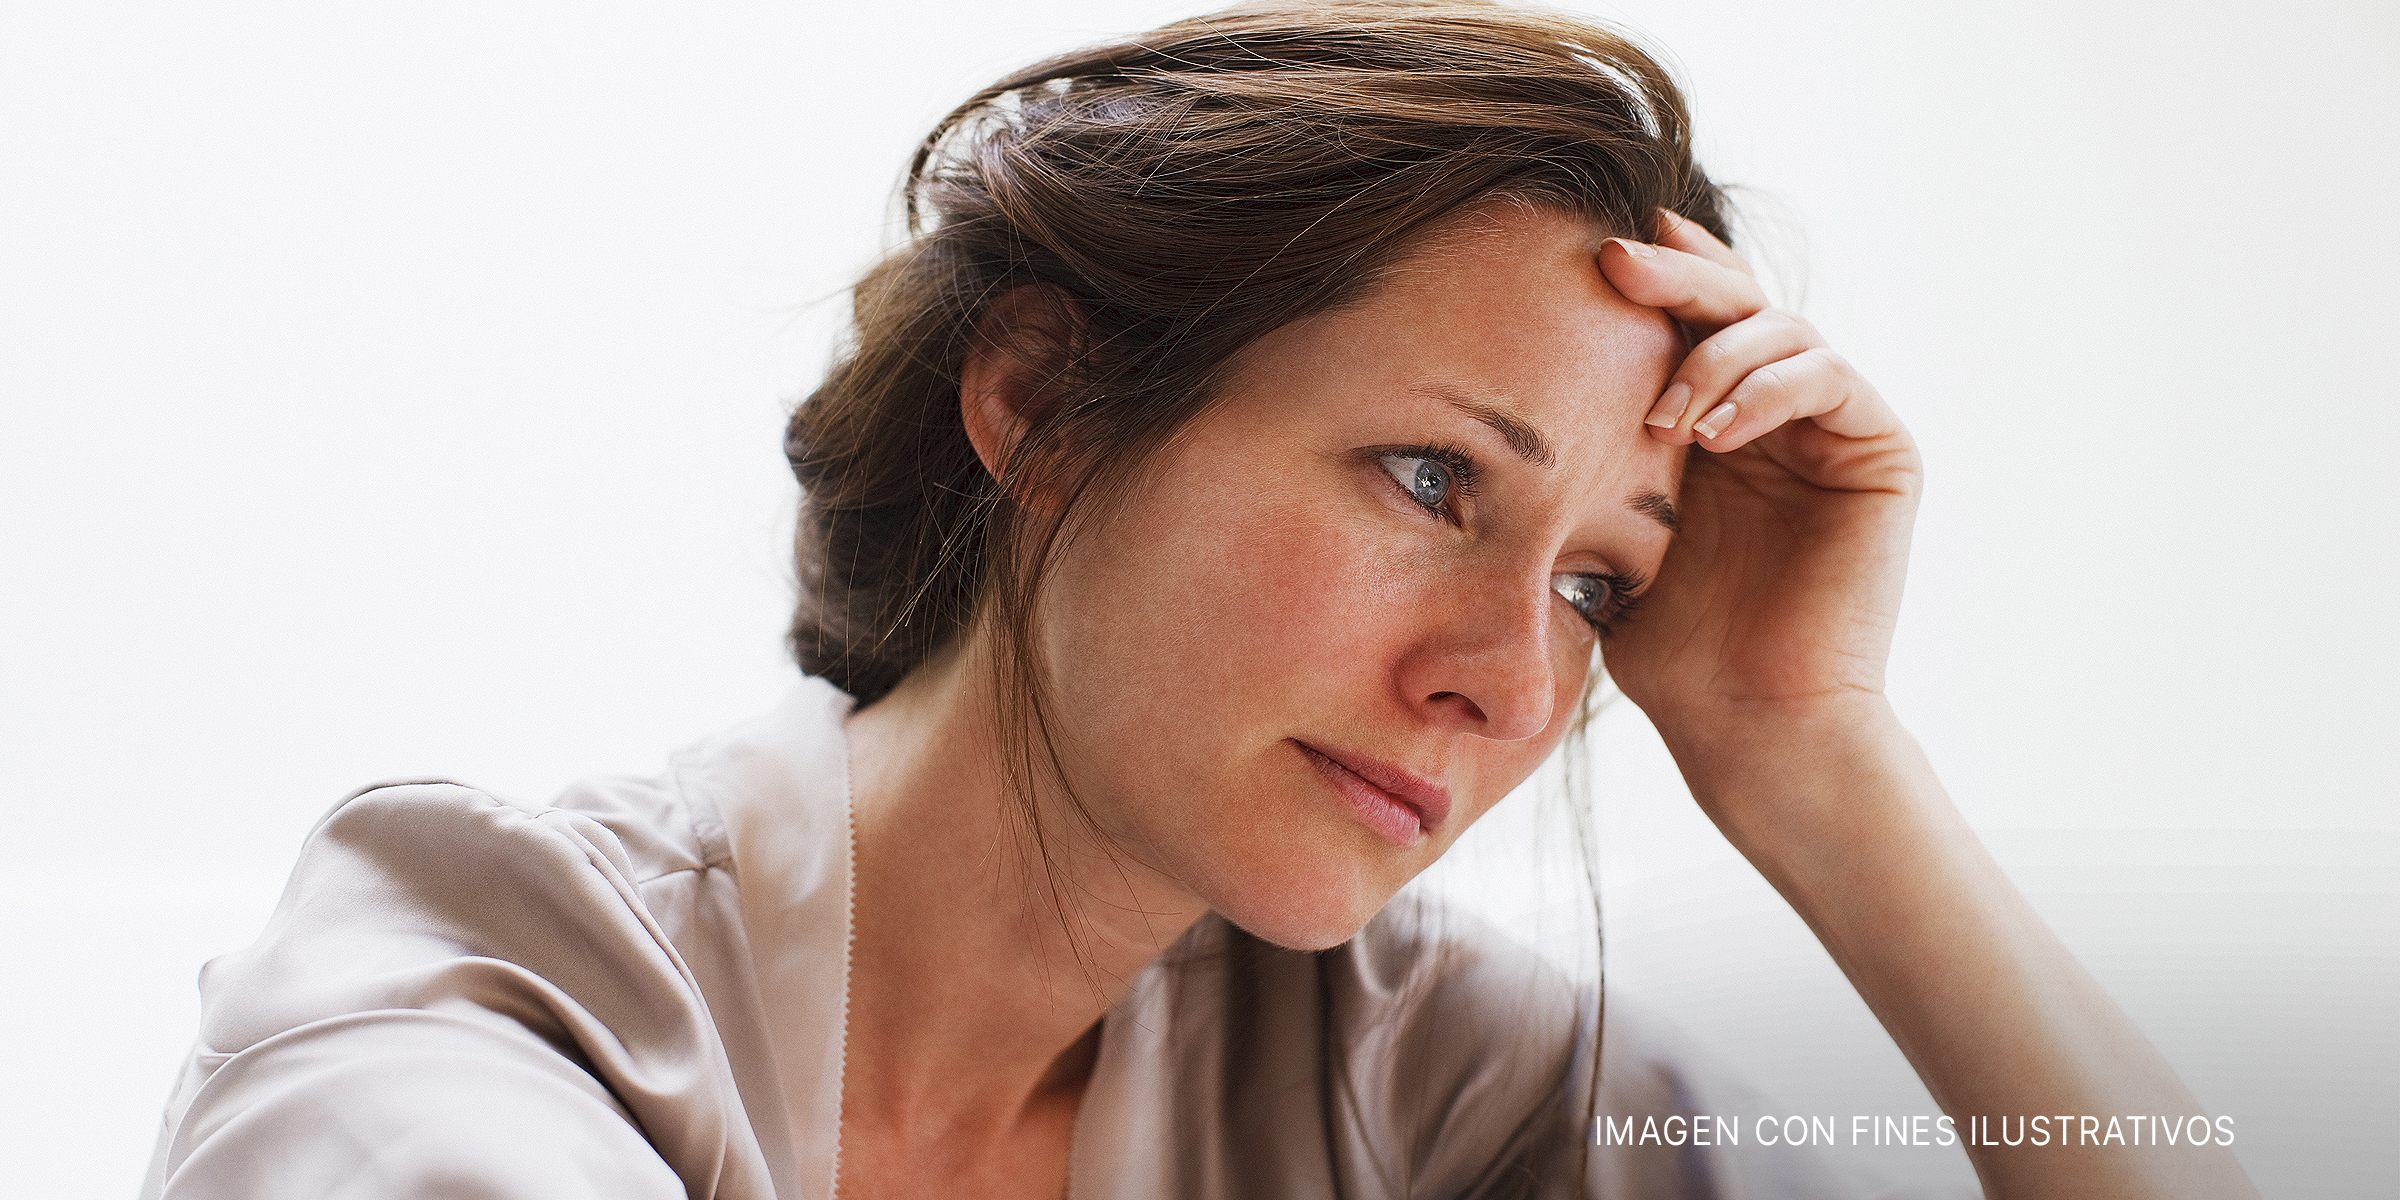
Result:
[1668, 696, 2256, 1198]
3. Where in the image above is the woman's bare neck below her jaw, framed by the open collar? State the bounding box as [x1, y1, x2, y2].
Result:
[842, 636, 1205, 1159]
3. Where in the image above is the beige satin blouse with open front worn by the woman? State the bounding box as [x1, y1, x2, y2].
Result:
[142, 679, 1910, 1200]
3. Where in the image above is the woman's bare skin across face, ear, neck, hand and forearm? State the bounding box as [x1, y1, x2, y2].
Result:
[840, 204, 2254, 1198]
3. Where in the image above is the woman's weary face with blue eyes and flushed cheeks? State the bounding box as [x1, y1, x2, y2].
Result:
[1039, 204, 1682, 948]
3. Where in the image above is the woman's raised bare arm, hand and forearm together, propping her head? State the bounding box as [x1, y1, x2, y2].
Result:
[1601, 218, 2256, 1198]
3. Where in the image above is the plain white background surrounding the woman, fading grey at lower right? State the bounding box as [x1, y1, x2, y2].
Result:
[0, 0, 2400, 1198]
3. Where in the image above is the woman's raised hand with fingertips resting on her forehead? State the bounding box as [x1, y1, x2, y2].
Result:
[1601, 214, 1922, 742]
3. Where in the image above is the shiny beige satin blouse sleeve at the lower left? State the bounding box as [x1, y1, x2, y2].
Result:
[144, 782, 773, 1200]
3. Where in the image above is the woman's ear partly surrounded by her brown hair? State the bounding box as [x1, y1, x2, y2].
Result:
[958, 283, 1078, 502]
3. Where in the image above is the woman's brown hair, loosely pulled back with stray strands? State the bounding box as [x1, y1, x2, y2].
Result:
[785, 0, 1726, 705]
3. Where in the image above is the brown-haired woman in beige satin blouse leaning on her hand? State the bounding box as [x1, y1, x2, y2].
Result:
[149, 5, 2249, 1198]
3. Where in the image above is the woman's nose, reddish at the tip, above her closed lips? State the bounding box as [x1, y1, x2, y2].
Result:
[1402, 581, 1558, 742]
